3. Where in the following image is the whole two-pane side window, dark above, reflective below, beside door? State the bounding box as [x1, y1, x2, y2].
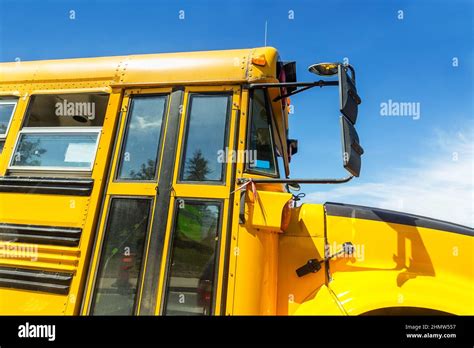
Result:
[9, 93, 109, 172]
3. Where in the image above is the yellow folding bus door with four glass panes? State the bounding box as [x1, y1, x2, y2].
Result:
[82, 87, 240, 315]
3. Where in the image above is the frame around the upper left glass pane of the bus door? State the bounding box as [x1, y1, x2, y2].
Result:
[112, 92, 171, 184]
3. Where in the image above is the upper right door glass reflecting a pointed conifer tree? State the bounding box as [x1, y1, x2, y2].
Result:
[180, 94, 231, 181]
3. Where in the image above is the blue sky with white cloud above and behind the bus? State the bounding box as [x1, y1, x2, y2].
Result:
[0, 0, 474, 225]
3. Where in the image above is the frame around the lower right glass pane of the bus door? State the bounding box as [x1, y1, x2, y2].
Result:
[160, 197, 226, 316]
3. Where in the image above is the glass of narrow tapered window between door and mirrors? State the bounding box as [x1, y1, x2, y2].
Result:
[248, 89, 276, 175]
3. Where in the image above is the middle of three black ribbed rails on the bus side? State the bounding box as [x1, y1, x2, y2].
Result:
[0, 223, 82, 246]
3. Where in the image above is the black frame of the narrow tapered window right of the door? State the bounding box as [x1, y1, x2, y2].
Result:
[244, 88, 280, 178]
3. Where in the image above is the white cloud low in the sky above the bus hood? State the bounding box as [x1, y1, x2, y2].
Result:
[306, 131, 474, 227]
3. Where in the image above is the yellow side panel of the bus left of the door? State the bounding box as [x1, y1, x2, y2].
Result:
[0, 88, 122, 315]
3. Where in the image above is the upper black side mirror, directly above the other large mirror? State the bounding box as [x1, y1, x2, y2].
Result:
[338, 64, 361, 124]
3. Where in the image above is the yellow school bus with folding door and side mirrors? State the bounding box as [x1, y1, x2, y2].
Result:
[0, 47, 474, 315]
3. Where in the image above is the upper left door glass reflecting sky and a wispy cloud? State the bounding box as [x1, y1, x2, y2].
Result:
[118, 96, 167, 180]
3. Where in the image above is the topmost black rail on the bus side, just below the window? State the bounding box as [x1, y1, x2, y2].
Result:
[0, 176, 94, 196]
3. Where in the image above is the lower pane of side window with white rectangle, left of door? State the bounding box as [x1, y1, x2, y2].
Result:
[11, 129, 100, 170]
